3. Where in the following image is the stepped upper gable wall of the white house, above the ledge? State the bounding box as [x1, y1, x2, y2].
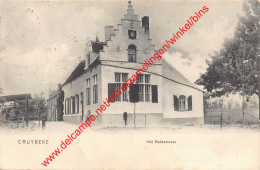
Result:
[100, 6, 157, 63]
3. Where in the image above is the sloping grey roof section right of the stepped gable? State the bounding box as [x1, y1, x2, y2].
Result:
[162, 59, 203, 92]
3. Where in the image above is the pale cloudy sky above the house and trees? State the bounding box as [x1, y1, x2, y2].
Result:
[0, 0, 242, 97]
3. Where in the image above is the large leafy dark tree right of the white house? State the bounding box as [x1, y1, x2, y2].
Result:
[196, 0, 260, 120]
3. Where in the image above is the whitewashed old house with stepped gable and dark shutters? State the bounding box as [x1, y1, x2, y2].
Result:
[62, 1, 203, 126]
